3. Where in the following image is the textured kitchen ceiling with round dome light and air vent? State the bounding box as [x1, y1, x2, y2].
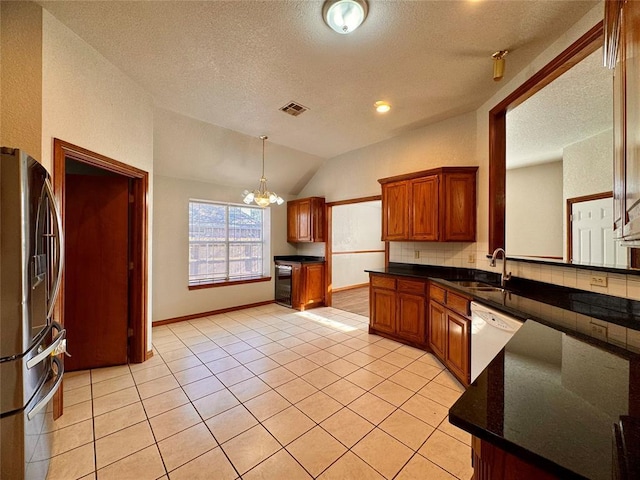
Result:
[39, 0, 599, 190]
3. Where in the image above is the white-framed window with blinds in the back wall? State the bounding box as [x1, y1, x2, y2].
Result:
[189, 200, 269, 286]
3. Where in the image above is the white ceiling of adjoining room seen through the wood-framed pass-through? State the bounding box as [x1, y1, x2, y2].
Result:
[507, 49, 613, 168]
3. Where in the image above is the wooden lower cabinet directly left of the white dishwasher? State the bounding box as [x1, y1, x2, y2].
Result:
[428, 284, 471, 386]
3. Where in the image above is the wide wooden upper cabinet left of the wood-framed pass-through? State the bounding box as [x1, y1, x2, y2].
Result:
[378, 167, 478, 242]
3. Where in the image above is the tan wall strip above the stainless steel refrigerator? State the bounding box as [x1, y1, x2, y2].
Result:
[0, 1, 42, 161]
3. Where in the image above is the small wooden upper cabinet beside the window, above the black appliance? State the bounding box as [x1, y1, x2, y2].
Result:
[287, 197, 325, 243]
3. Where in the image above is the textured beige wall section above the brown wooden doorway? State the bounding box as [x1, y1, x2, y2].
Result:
[42, 10, 153, 173]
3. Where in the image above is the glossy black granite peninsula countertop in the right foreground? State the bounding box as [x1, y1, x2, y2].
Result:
[449, 320, 640, 480]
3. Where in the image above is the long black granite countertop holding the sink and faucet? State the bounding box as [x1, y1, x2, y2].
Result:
[367, 263, 640, 330]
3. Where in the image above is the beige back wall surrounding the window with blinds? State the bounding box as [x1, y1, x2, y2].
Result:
[153, 175, 295, 321]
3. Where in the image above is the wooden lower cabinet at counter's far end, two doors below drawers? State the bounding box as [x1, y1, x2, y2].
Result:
[369, 274, 427, 348]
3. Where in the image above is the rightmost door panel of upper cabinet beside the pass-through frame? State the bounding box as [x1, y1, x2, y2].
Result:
[440, 173, 476, 242]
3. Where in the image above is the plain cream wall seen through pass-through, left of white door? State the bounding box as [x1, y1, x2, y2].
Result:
[505, 160, 566, 258]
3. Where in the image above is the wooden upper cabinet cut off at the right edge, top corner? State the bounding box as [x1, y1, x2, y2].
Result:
[605, 0, 640, 242]
